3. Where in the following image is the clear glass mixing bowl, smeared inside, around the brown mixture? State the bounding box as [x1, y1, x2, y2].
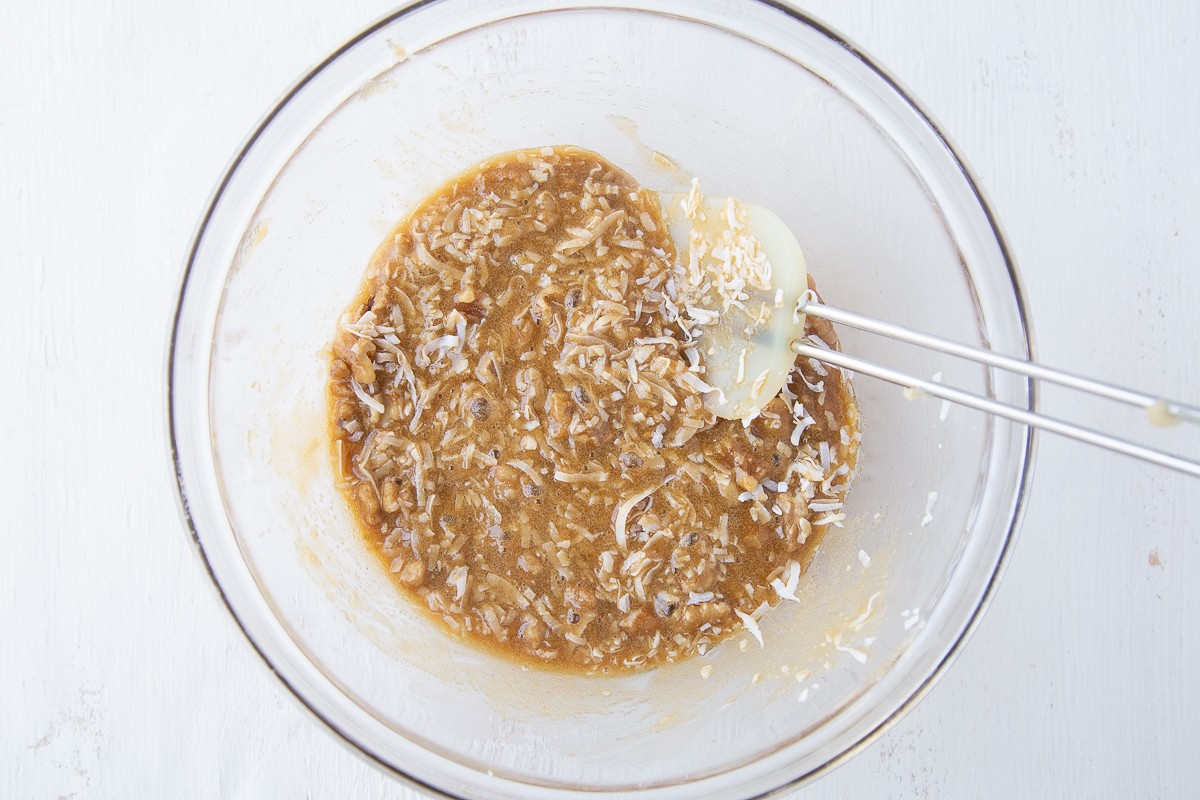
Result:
[169, 0, 1034, 800]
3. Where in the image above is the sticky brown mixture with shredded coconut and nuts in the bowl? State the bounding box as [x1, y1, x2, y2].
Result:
[330, 148, 859, 672]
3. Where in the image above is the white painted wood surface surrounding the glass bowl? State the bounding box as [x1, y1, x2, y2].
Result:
[0, 0, 1200, 800]
